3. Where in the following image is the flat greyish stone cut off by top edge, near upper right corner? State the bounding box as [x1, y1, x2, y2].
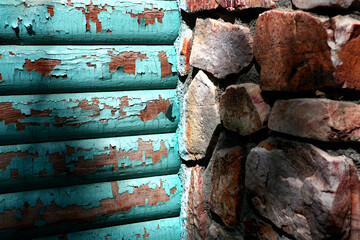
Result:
[292, 0, 354, 9]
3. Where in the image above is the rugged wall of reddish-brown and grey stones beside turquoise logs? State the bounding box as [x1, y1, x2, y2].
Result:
[177, 0, 360, 240]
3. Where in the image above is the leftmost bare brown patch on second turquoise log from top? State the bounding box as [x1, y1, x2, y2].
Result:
[23, 58, 61, 78]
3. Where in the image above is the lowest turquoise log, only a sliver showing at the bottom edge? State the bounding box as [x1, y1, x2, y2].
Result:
[36, 217, 181, 240]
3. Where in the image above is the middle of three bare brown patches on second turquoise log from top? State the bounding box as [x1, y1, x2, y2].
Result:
[106, 51, 147, 75]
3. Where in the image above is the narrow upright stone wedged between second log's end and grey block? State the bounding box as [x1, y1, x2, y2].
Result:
[176, 23, 193, 76]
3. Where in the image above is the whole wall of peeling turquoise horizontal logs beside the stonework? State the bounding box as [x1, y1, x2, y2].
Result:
[0, 0, 182, 239]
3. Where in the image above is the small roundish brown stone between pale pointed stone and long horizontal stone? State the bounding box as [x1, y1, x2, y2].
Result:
[220, 83, 270, 136]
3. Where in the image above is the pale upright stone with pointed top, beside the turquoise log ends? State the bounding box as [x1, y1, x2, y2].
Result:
[179, 71, 220, 160]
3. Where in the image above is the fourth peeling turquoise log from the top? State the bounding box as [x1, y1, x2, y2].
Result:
[0, 133, 180, 193]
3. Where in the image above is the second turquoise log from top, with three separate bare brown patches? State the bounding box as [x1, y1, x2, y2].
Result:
[0, 45, 178, 94]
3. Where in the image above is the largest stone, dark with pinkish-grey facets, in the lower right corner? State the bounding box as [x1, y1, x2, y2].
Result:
[245, 138, 360, 240]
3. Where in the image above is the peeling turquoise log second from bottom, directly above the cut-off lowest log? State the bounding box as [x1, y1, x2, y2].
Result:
[0, 175, 182, 239]
